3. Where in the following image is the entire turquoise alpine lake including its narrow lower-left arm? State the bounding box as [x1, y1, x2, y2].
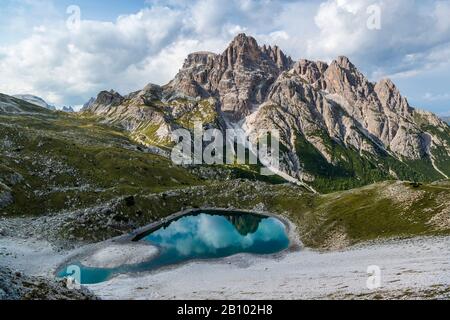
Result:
[58, 211, 289, 284]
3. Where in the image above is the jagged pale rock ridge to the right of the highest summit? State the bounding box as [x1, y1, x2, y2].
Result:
[292, 57, 427, 159]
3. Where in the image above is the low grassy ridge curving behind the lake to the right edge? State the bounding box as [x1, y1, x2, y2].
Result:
[51, 180, 450, 249]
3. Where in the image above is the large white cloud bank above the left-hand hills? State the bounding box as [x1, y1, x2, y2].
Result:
[0, 8, 185, 104]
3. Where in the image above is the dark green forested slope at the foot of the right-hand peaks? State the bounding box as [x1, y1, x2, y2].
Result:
[296, 132, 432, 193]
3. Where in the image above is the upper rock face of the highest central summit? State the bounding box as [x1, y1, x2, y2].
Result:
[169, 34, 293, 120]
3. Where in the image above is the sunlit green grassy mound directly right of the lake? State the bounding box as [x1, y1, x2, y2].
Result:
[293, 182, 450, 247]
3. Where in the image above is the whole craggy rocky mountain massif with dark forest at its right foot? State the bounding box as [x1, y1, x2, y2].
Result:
[84, 34, 450, 191]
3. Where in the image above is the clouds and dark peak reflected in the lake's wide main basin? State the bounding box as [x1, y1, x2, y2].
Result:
[144, 213, 288, 258]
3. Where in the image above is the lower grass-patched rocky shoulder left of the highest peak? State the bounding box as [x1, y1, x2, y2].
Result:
[83, 84, 223, 147]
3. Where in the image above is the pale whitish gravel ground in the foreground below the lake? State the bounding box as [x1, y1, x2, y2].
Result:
[0, 237, 450, 299]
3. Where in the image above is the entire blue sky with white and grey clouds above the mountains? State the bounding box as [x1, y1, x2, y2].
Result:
[0, 0, 450, 115]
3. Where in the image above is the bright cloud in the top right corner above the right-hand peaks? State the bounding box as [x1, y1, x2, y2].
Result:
[308, 0, 450, 76]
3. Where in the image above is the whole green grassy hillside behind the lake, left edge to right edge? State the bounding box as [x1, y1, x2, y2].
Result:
[0, 96, 450, 248]
